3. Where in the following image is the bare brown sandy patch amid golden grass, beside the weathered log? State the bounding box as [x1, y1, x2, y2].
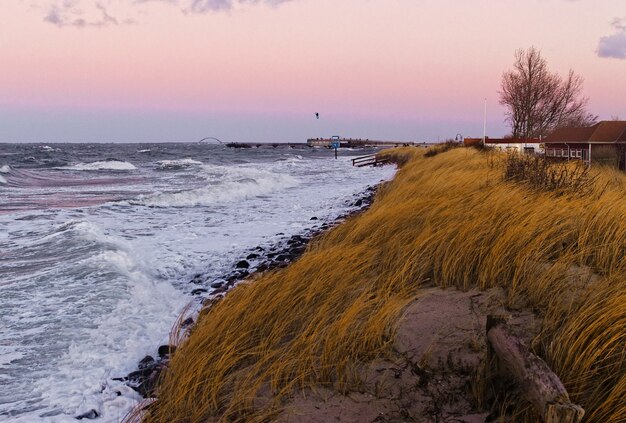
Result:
[278, 288, 539, 423]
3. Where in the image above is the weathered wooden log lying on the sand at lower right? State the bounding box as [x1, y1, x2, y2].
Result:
[487, 316, 585, 423]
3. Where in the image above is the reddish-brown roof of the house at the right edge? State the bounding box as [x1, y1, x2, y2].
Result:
[543, 120, 626, 144]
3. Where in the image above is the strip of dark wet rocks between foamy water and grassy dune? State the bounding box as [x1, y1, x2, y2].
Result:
[95, 186, 378, 420]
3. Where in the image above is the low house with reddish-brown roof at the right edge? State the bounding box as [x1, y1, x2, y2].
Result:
[543, 120, 626, 170]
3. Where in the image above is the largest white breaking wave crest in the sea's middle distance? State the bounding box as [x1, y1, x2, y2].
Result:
[133, 165, 300, 207]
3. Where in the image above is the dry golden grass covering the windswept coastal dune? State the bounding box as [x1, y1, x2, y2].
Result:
[144, 148, 626, 423]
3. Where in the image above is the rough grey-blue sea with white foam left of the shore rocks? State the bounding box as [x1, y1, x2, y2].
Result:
[0, 143, 395, 422]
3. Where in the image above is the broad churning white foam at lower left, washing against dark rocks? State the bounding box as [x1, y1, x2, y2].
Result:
[0, 220, 189, 422]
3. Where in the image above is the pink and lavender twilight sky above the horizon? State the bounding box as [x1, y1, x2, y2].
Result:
[0, 0, 626, 143]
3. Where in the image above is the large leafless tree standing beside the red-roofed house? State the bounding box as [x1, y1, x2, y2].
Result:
[499, 47, 597, 138]
